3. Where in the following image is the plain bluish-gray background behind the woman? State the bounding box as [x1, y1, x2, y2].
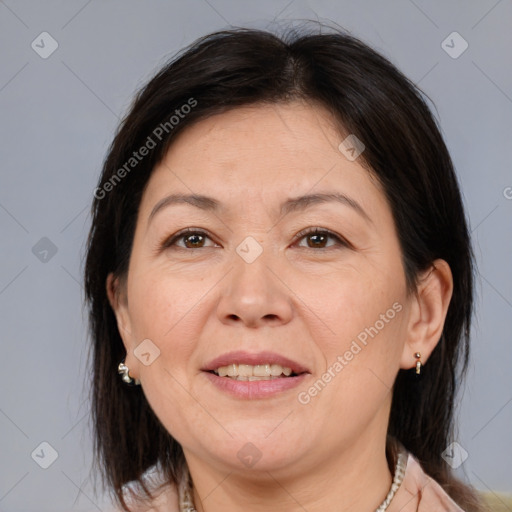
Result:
[0, 0, 512, 512]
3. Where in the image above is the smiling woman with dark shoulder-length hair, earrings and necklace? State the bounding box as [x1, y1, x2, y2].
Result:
[85, 27, 483, 512]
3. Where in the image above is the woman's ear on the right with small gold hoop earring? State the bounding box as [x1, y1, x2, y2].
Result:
[400, 259, 453, 369]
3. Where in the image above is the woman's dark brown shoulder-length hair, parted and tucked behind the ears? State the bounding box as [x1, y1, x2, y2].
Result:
[85, 23, 481, 512]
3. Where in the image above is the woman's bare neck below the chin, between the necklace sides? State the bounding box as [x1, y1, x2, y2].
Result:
[186, 418, 393, 512]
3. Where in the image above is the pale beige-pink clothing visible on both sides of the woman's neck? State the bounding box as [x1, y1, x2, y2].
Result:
[123, 453, 464, 512]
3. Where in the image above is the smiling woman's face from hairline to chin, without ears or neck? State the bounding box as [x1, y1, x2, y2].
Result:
[112, 102, 414, 474]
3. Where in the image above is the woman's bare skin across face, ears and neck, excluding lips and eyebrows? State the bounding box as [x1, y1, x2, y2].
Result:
[107, 101, 453, 512]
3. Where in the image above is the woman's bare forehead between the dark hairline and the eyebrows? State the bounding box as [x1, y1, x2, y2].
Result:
[138, 101, 385, 220]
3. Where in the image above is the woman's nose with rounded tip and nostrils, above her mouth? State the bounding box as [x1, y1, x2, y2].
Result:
[217, 244, 293, 328]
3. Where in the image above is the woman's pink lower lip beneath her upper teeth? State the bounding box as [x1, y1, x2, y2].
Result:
[203, 372, 308, 400]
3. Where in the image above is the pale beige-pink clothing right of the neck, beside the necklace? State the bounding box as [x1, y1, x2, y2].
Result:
[388, 453, 464, 512]
